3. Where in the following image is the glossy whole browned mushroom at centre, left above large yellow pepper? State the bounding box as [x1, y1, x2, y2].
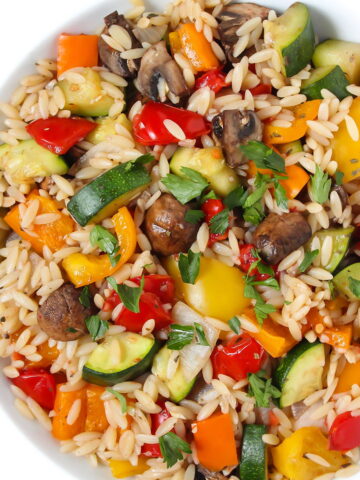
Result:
[145, 193, 199, 256]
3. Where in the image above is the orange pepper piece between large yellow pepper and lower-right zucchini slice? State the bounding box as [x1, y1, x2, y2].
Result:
[243, 309, 297, 358]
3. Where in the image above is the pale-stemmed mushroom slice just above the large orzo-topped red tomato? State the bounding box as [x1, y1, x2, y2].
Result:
[137, 41, 189, 100]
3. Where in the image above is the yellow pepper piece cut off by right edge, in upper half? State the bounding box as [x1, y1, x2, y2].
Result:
[331, 98, 360, 182]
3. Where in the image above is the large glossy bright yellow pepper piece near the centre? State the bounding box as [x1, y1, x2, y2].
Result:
[164, 256, 250, 322]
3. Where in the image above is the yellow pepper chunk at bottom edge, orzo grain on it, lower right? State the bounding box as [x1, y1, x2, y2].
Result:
[271, 427, 348, 480]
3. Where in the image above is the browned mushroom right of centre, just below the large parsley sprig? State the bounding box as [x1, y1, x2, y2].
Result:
[254, 212, 311, 265]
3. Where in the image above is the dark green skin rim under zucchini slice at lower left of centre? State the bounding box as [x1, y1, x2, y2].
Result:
[82, 339, 161, 387]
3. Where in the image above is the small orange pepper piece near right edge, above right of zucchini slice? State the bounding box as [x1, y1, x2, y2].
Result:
[306, 308, 353, 349]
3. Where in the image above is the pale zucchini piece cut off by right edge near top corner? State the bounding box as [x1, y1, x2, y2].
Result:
[313, 40, 360, 85]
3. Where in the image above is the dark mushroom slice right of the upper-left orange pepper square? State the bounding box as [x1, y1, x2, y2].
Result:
[99, 11, 141, 78]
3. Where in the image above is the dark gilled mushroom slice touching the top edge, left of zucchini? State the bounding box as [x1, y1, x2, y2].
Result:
[216, 3, 270, 63]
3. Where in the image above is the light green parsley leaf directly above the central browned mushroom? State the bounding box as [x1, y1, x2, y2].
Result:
[161, 167, 209, 204]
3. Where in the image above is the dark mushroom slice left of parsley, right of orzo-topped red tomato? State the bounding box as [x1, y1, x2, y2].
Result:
[212, 110, 263, 168]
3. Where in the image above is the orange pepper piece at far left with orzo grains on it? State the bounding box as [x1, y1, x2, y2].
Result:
[4, 190, 75, 255]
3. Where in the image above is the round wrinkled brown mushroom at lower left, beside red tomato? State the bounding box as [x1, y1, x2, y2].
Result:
[38, 283, 95, 342]
